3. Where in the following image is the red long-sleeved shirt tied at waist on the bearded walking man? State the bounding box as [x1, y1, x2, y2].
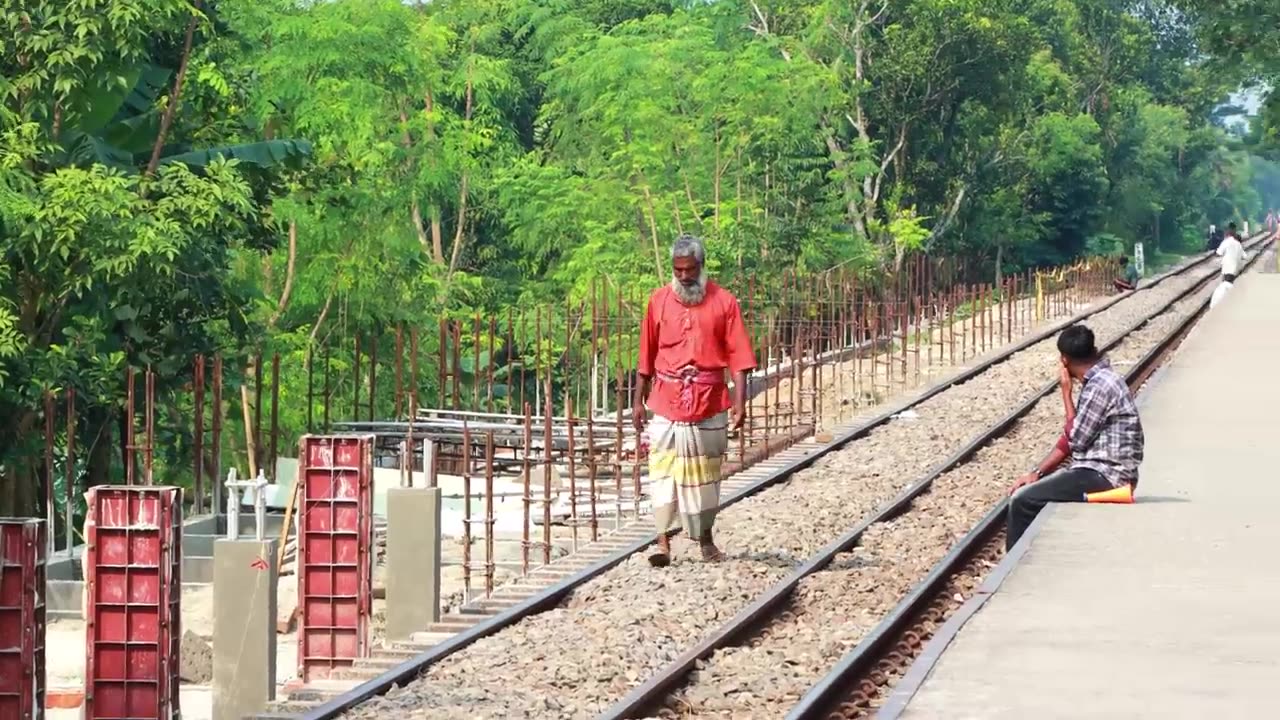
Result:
[636, 281, 755, 423]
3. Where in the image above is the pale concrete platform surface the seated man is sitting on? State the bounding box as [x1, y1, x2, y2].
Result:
[882, 273, 1280, 720]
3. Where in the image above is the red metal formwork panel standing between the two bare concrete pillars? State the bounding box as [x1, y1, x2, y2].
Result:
[298, 434, 374, 682]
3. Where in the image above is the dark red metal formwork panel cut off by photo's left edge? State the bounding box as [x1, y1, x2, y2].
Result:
[0, 518, 47, 720]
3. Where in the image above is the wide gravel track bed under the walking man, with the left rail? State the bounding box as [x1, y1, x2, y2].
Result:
[273, 233, 1269, 720]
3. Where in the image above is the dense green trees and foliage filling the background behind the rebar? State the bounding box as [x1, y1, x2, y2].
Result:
[0, 0, 1280, 514]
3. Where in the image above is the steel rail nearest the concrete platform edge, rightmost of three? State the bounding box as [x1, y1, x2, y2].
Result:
[786, 238, 1272, 720]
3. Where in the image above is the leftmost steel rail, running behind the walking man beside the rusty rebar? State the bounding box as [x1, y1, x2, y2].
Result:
[294, 241, 1252, 720]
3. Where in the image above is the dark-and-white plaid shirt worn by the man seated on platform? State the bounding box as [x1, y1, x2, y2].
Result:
[1071, 360, 1143, 487]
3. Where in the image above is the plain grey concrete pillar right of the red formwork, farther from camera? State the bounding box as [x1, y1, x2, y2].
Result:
[385, 488, 442, 639]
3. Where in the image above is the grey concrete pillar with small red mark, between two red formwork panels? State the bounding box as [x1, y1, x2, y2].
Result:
[214, 539, 279, 720]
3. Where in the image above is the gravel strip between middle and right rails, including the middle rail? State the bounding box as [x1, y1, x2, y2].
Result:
[588, 237, 1257, 719]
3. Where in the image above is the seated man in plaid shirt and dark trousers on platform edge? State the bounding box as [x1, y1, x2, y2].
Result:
[1005, 325, 1143, 548]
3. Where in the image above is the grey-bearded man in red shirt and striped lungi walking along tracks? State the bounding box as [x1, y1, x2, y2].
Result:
[632, 234, 755, 568]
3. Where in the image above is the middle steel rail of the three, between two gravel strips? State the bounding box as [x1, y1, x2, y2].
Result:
[598, 233, 1266, 720]
